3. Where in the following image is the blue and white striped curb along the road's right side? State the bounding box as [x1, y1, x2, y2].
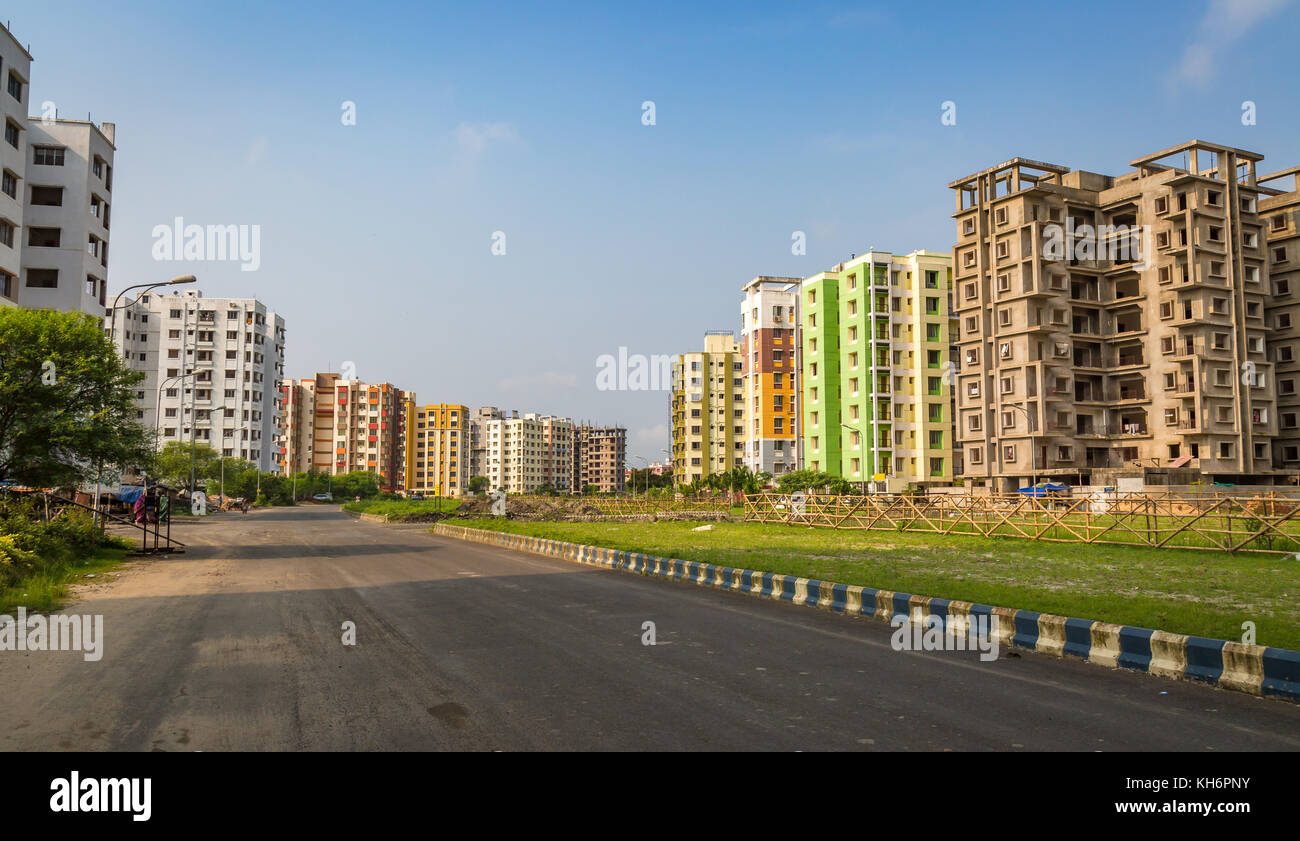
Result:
[433, 523, 1300, 701]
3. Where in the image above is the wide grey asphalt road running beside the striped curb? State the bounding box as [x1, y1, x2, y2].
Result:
[0, 506, 1300, 751]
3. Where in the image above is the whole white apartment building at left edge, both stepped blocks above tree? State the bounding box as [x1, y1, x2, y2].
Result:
[0, 26, 116, 317]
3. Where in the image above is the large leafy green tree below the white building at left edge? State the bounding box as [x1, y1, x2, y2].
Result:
[0, 307, 152, 486]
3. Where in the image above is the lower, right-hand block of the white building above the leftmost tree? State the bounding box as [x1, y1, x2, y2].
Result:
[21, 118, 114, 316]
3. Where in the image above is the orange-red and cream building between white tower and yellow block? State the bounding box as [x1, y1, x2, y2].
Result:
[277, 373, 415, 491]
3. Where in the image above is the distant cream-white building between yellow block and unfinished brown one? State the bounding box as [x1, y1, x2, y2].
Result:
[481, 412, 573, 494]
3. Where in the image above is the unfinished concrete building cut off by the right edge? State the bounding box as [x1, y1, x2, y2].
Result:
[1258, 166, 1300, 477]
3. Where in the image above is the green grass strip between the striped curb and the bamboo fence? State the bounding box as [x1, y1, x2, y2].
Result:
[458, 519, 1300, 650]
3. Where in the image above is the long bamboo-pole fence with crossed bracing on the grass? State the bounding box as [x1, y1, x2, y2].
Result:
[745, 493, 1300, 554]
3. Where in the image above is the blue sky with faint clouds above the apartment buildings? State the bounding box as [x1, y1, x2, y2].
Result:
[4, 0, 1300, 464]
